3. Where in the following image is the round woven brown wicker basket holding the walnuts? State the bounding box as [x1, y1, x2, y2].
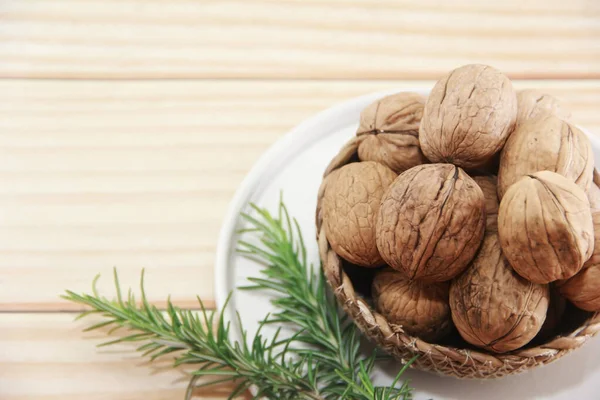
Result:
[316, 137, 600, 379]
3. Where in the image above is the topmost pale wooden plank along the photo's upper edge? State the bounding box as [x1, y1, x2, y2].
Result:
[0, 0, 600, 79]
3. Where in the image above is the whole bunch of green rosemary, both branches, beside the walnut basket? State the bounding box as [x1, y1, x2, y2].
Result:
[63, 198, 412, 400]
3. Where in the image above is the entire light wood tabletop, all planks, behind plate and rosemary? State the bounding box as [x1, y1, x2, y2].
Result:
[0, 0, 600, 400]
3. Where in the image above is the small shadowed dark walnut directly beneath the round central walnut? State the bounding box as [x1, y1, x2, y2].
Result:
[372, 268, 452, 342]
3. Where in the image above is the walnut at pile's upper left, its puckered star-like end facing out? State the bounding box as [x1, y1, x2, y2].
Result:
[356, 92, 428, 173]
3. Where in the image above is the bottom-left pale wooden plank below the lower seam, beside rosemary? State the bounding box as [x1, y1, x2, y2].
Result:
[0, 313, 241, 400]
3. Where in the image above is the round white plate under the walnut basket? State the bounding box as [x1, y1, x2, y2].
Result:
[216, 89, 600, 400]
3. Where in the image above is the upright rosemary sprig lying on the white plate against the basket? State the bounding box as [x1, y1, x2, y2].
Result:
[238, 200, 410, 399]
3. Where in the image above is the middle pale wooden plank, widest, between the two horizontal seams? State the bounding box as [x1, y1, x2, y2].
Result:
[0, 80, 600, 311]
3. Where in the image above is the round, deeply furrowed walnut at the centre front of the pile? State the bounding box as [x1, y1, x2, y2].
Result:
[376, 164, 485, 282]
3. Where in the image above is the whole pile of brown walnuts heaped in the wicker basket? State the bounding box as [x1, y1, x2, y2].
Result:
[320, 65, 600, 353]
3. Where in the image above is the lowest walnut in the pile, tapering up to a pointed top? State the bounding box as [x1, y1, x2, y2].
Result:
[450, 233, 549, 353]
